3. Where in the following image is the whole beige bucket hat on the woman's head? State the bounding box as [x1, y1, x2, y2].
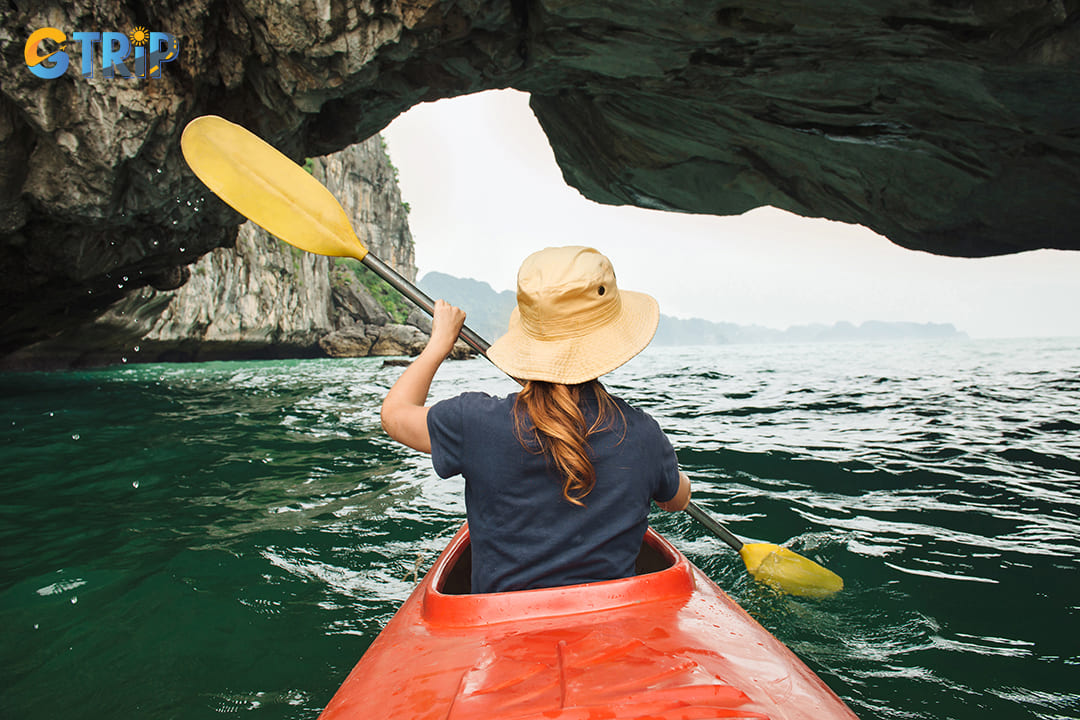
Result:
[487, 245, 660, 385]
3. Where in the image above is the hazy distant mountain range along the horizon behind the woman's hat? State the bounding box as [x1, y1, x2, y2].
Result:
[419, 272, 968, 345]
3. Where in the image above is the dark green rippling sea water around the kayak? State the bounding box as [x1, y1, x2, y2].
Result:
[0, 340, 1080, 720]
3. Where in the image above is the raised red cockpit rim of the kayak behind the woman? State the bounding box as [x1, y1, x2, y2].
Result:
[421, 526, 694, 627]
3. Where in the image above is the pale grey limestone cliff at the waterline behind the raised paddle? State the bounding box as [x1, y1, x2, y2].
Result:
[4, 136, 426, 367]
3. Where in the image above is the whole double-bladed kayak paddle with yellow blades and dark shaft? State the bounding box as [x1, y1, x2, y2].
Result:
[180, 116, 843, 597]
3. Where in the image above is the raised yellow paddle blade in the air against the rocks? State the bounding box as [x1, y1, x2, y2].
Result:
[174, 116, 367, 260]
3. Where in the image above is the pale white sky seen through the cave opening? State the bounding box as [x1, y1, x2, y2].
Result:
[383, 91, 1080, 338]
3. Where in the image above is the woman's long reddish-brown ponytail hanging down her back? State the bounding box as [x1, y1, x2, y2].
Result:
[514, 380, 625, 506]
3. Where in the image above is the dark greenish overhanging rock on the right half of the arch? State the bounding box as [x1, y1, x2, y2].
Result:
[532, 1, 1080, 256]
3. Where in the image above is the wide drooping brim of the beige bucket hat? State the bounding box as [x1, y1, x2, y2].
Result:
[487, 290, 660, 385]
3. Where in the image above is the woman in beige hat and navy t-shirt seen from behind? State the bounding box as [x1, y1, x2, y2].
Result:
[382, 246, 690, 593]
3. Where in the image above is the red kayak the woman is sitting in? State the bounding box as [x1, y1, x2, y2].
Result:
[320, 528, 855, 720]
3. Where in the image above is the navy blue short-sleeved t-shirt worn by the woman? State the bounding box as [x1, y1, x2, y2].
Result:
[428, 391, 679, 593]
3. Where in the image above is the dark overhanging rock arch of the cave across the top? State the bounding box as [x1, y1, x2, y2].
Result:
[0, 0, 1080, 353]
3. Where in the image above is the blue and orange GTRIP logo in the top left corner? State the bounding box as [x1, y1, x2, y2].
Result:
[23, 27, 180, 80]
